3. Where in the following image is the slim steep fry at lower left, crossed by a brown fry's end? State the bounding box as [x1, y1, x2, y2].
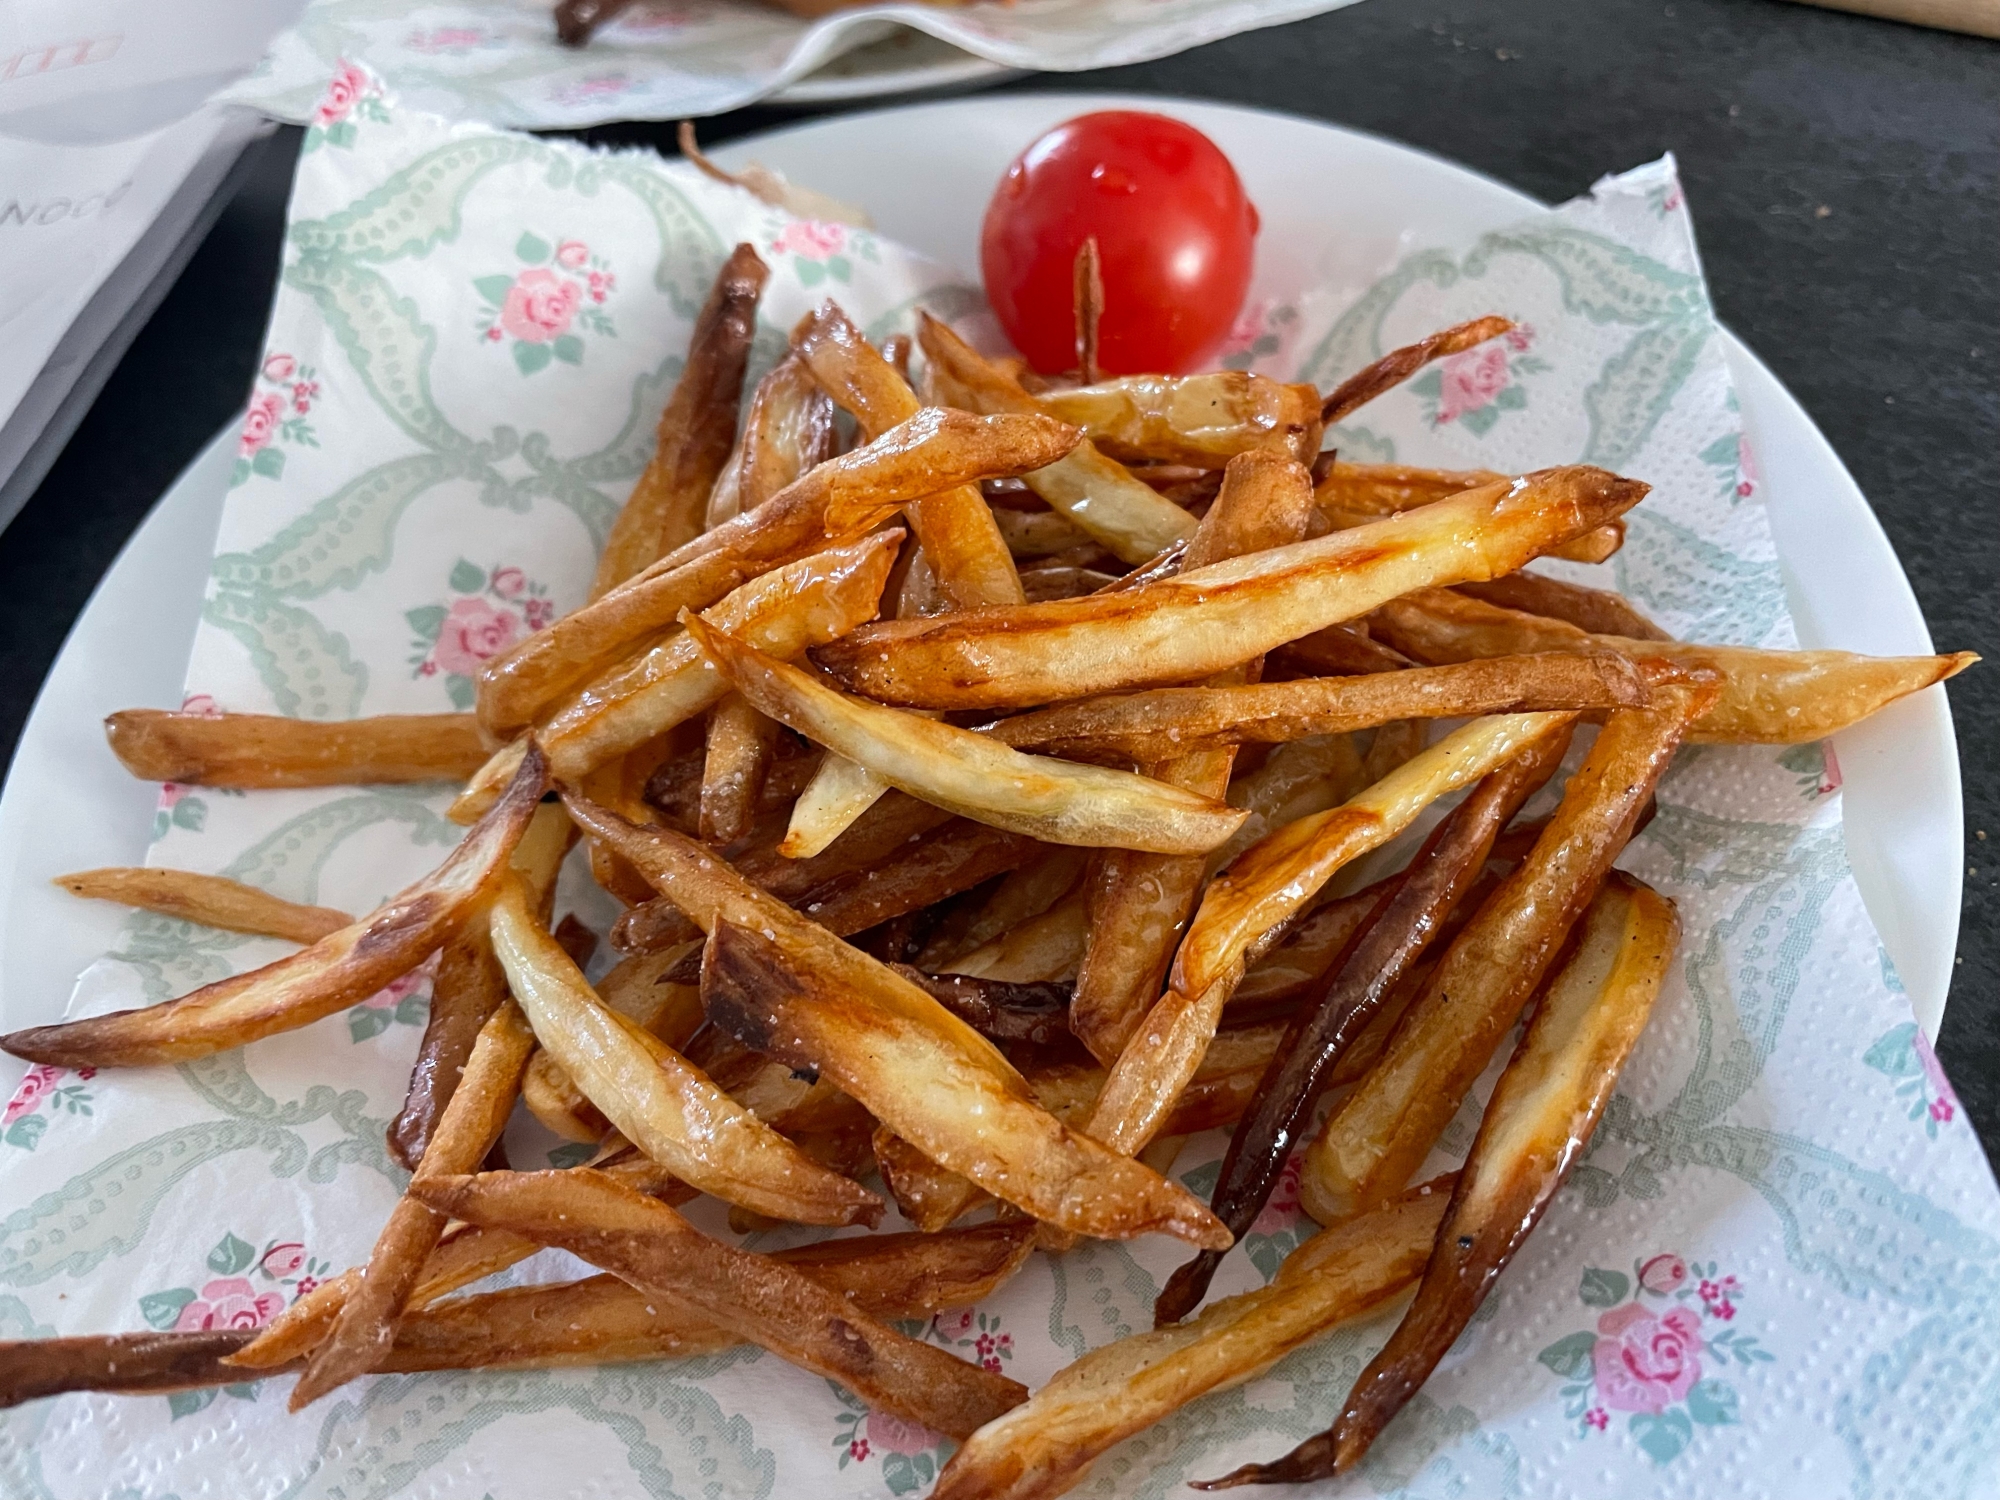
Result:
[290, 1000, 534, 1412]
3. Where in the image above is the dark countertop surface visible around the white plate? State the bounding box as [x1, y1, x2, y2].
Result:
[0, 0, 2000, 1160]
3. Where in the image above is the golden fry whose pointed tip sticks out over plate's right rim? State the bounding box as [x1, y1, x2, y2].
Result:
[1376, 590, 1980, 744]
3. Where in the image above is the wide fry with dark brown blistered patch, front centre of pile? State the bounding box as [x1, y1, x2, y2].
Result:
[568, 798, 1212, 1242]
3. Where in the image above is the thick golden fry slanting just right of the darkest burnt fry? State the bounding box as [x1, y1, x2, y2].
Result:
[1300, 684, 1716, 1224]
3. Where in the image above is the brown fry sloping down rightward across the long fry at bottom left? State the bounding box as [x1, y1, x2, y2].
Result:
[412, 1168, 1026, 1436]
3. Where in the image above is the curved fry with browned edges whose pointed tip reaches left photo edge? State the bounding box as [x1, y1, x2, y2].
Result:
[0, 750, 548, 1068]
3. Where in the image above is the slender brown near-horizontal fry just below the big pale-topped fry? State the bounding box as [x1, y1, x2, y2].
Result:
[984, 652, 1646, 760]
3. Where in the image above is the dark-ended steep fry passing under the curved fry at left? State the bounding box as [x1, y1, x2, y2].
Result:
[388, 802, 576, 1172]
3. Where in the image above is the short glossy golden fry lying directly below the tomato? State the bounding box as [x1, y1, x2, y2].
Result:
[1036, 370, 1320, 468]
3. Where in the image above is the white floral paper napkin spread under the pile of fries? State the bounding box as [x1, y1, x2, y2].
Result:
[0, 70, 2000, 1500]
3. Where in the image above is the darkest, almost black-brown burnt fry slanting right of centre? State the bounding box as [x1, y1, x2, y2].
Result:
[1154, 734, 1568, 1324]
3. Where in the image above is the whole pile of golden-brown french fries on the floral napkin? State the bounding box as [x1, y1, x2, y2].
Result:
[0, 246, 1974, 1498]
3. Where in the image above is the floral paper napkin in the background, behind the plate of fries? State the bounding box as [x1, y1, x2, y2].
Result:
[226, 0, 1354, 130]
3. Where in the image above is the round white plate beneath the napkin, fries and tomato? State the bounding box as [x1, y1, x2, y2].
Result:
[0, 94, 1964, 1104]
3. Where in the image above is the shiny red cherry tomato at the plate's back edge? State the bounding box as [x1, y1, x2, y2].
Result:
[980, 110, 1258, 374]
